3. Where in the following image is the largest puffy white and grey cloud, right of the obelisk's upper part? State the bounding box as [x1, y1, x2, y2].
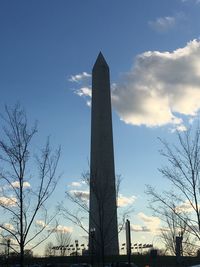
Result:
[112, 40, 200, 129]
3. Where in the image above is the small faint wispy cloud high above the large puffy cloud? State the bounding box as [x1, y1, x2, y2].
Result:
[149, 16, 176, 32]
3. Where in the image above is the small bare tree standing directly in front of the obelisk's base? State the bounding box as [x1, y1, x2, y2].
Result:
[61, 172, 131, 263]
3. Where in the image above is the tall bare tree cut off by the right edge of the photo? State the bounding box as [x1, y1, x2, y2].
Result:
[146, 126, 200, 255]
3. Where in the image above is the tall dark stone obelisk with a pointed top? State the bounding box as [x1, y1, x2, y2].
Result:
[89, 53, 119, 257]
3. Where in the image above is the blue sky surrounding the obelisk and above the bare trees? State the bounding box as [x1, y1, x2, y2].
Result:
[0, 0, 200, 255]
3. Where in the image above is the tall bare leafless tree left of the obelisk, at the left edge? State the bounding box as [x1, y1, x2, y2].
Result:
[0, 105, 60, 267]
